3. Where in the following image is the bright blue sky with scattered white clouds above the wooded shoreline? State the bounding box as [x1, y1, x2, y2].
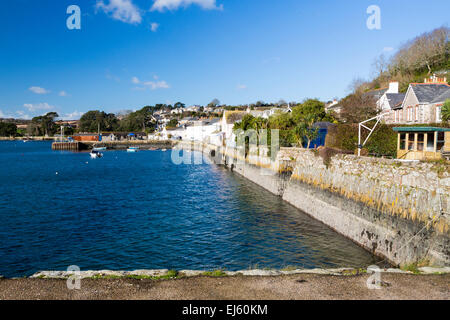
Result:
[0, 0, 450, 119]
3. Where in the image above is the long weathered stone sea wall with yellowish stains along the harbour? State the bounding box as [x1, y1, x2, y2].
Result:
[180, 144, 450, 266]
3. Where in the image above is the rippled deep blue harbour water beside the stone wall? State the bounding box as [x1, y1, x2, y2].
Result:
[0, 142, 376, 277]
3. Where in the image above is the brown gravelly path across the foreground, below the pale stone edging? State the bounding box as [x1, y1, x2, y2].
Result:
[0, 274, 450, 300]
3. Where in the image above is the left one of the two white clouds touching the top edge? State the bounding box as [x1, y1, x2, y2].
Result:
[96, 0, 142, 24]
